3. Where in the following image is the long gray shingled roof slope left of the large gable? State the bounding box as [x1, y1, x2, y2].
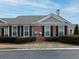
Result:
[1, 15, 45, 25]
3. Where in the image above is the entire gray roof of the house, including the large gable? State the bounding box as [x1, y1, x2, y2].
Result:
[0, 13, 71, 25]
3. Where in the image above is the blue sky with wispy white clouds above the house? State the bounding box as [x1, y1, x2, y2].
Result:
[0, 0, 79, 24]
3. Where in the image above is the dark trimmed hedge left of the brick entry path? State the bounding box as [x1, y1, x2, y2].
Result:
[0, 37, 36, 44]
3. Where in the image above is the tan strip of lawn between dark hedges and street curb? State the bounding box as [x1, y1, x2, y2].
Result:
[0, 42, 79, 49]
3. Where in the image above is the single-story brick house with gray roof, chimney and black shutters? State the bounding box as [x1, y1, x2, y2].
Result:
[0, 10, 73, 37]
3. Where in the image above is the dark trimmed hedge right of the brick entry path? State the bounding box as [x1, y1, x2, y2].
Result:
[45, 36, 79, 45]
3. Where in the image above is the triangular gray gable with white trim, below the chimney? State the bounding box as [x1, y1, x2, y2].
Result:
[38, 13, 71, 24]
